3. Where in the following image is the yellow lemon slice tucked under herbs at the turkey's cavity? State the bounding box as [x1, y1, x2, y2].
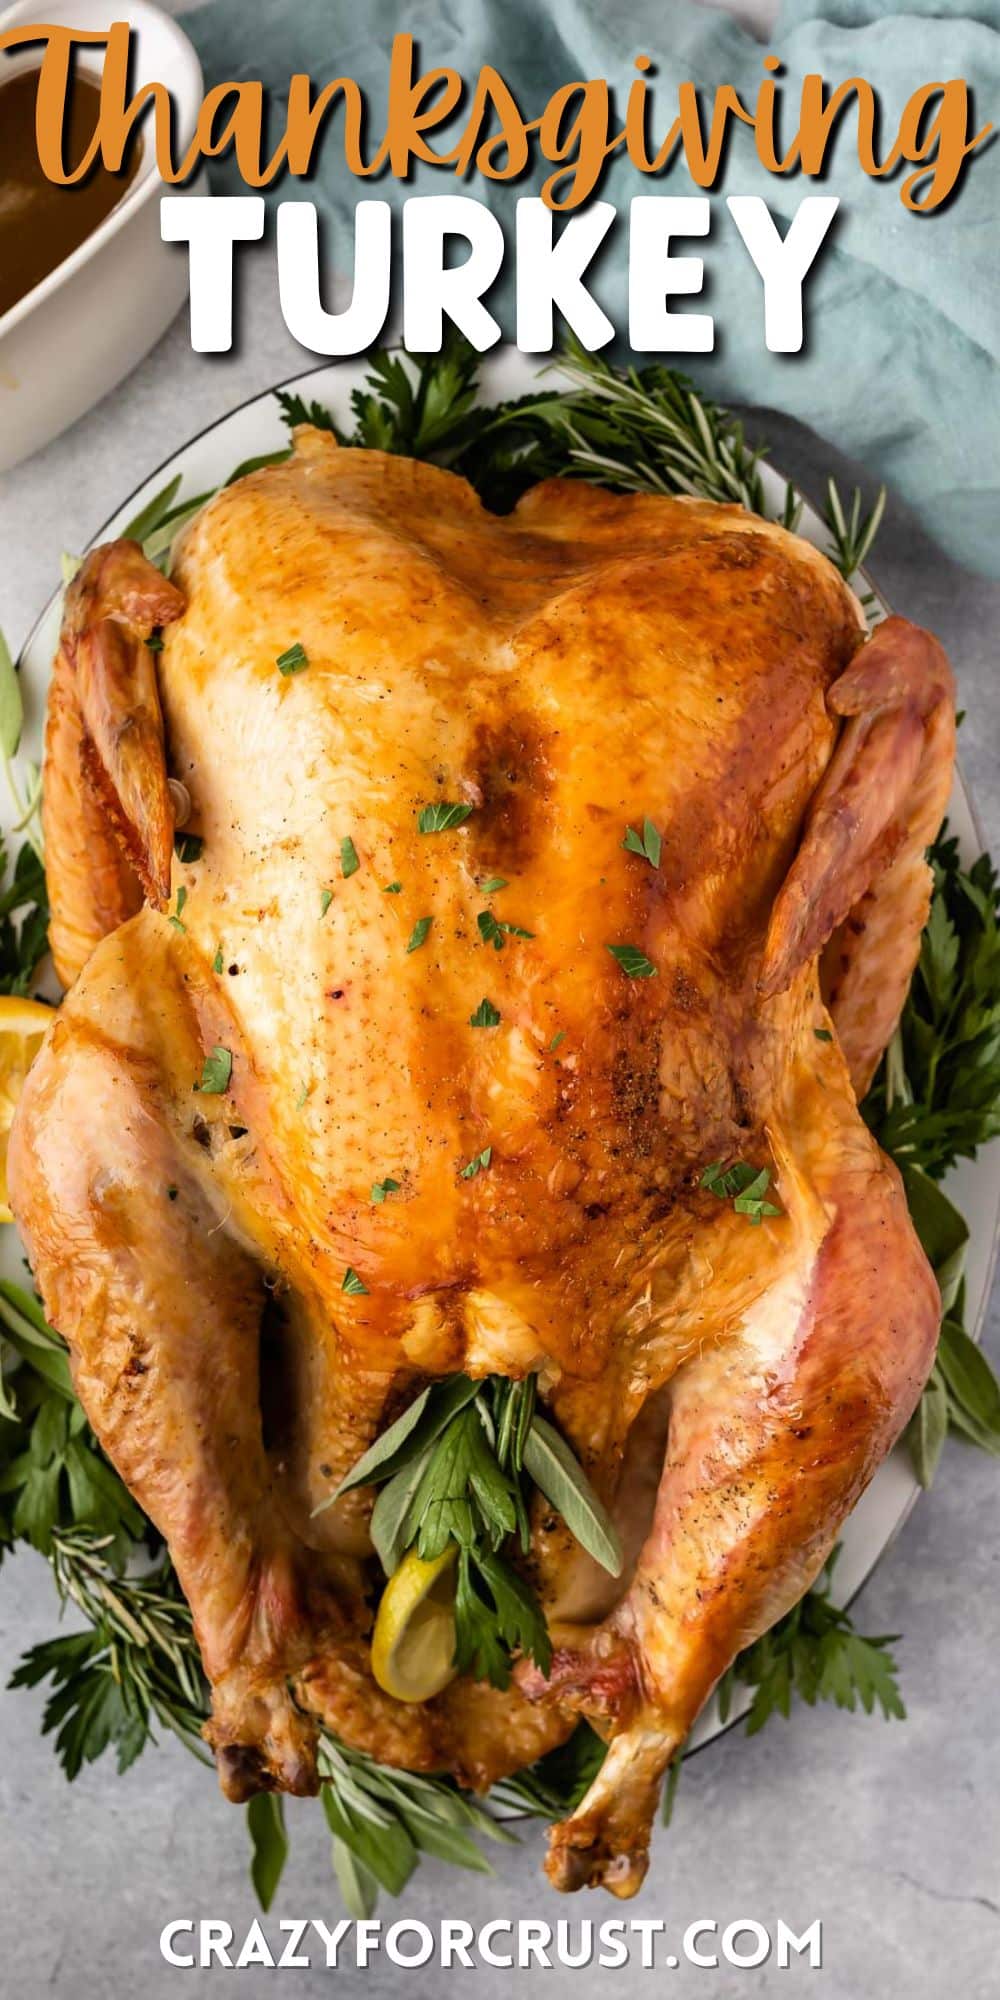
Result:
[372, 1542, 456, 1702]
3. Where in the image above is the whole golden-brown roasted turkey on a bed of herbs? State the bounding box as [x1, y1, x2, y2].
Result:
[10, 428, 954, 1896]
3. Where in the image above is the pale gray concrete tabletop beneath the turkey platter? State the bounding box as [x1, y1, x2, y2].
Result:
[0, 0, 1000, 2000]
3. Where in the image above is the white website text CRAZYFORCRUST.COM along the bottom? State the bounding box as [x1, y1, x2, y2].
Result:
[160, 1916, 822, 1972]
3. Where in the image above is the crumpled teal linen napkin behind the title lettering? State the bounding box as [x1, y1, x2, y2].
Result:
[184, 0, 1000, 576]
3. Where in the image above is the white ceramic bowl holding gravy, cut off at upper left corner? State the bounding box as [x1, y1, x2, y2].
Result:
[0, 0, 202, 472]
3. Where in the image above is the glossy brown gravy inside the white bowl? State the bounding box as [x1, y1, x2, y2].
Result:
[0, 70, 142, 312]
